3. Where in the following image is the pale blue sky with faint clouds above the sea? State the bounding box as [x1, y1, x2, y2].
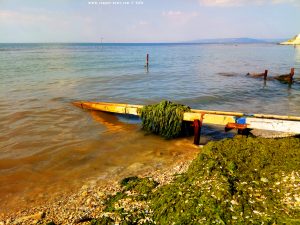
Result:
[0, 0, 300, 43]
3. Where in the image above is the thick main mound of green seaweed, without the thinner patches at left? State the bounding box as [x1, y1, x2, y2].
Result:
[152, 138, 300, 224]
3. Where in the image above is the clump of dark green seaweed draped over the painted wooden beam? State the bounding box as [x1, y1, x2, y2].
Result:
[140, 101, 190, 139]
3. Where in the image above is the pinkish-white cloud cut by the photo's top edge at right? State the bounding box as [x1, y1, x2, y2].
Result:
[198, 0, 300, 7]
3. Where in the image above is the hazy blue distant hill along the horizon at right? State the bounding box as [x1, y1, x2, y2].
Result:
[189, 38, 282, 44]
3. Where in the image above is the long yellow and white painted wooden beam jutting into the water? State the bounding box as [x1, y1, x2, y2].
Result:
[73, 102, 300, 144]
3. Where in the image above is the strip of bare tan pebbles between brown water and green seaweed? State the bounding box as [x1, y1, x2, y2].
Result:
[0, 143, 200, 225]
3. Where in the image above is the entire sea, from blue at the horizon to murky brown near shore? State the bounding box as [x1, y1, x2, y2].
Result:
[0, 44, 300, 213]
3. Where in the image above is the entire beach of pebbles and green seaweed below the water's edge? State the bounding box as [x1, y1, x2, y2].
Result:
[0, 135, 300, 225]
